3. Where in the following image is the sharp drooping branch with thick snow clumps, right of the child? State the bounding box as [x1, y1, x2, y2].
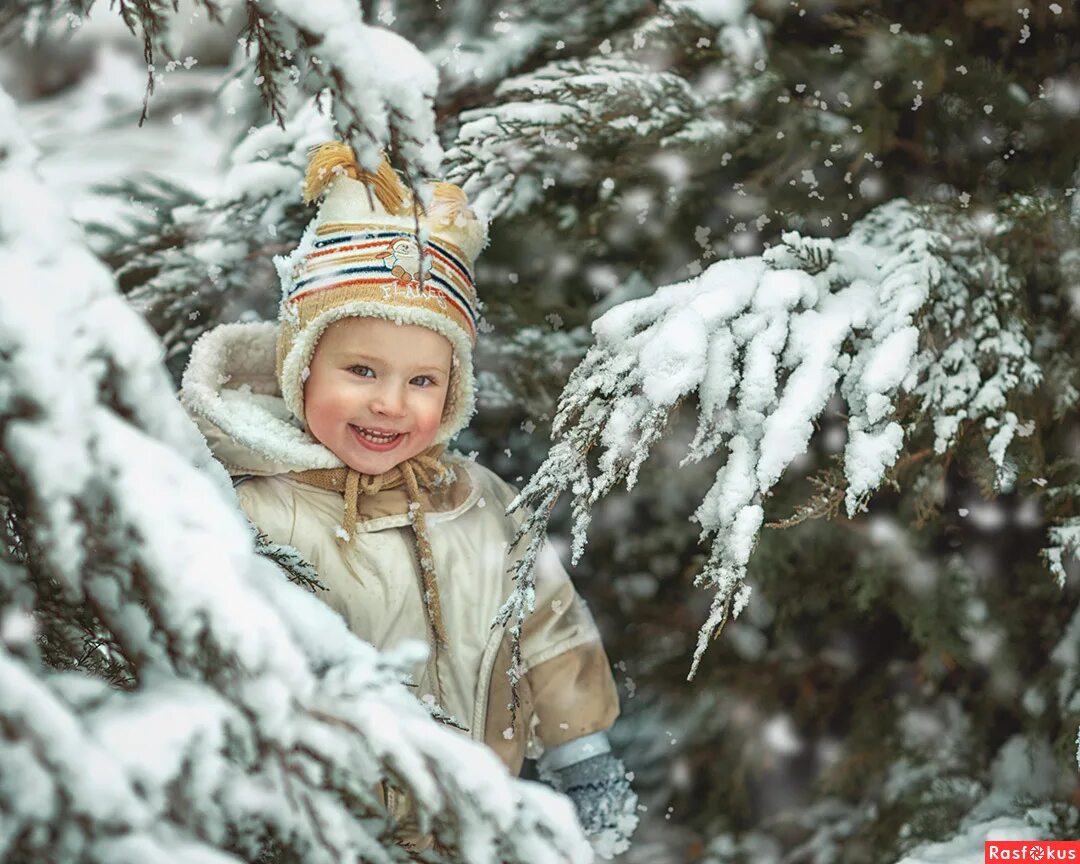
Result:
[508, 200, 1041, 677]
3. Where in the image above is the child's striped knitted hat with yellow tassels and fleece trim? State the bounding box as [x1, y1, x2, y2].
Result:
[274, 141, 487, 444]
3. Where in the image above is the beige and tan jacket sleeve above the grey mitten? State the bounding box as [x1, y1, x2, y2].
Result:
[522, 539, 619, 747]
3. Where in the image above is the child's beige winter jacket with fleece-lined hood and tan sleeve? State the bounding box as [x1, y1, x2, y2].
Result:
[181, 324, 619, 774]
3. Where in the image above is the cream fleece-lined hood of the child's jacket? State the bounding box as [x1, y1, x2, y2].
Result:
[180, 322, 345, 476]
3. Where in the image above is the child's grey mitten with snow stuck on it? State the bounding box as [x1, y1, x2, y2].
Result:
[541, 739, 637, 858]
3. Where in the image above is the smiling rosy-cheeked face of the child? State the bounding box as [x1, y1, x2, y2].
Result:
[303, 318, 451, 474]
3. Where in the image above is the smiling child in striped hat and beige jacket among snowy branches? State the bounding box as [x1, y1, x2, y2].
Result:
[181, 143, 635, 848]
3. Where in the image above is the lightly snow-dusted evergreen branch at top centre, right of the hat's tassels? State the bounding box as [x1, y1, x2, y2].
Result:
[446, 3, 767, 219]
